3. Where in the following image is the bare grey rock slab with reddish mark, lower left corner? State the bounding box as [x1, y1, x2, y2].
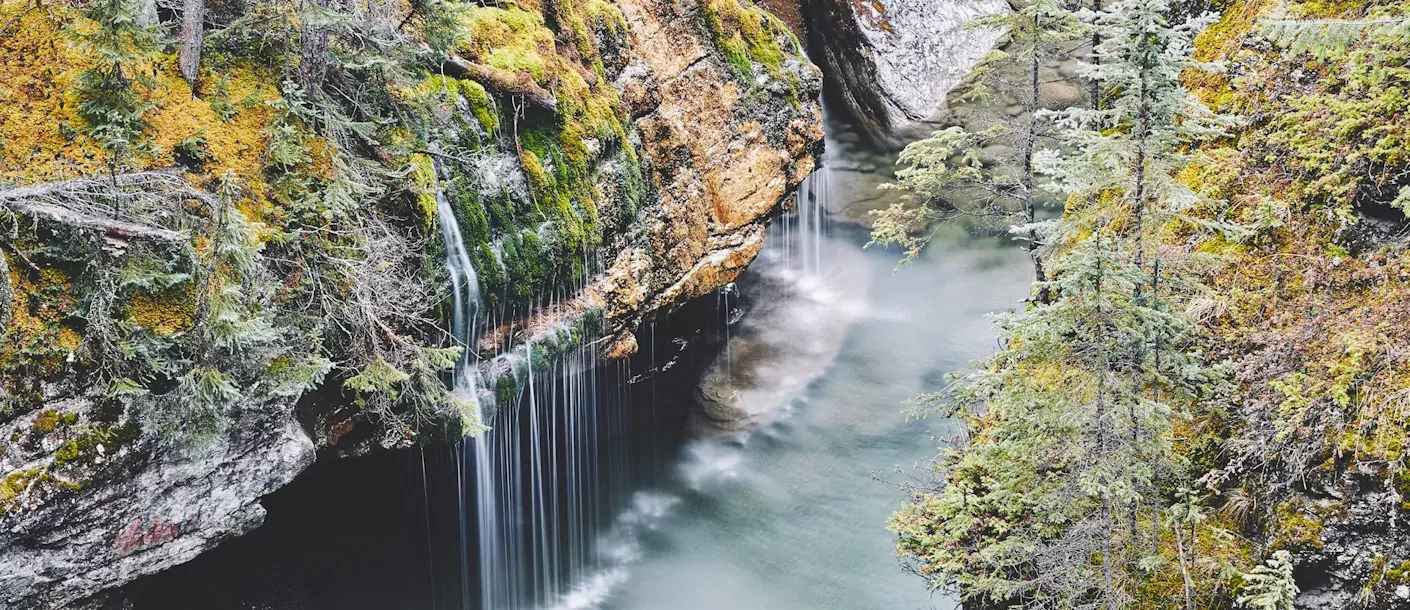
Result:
[0, 399, 314, 610]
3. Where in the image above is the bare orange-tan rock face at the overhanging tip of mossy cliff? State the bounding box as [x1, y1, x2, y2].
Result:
[598, 0, 822, 346]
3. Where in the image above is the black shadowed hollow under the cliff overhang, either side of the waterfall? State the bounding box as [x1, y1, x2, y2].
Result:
[125, 287, 733, 610]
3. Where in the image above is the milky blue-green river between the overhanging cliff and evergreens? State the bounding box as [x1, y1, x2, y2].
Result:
[589, 119, 1031, 610]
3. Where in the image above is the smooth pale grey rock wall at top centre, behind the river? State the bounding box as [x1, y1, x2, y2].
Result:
[804, 0, 1005, 141]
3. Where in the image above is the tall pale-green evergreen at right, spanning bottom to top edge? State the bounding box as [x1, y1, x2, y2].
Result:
[891, 0, 1230, 602]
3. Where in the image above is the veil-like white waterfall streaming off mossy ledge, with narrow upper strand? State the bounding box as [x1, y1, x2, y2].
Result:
[431, 168, 664, 610]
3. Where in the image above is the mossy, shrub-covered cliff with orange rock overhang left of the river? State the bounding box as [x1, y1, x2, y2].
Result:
[0, 0, 822, 602]
